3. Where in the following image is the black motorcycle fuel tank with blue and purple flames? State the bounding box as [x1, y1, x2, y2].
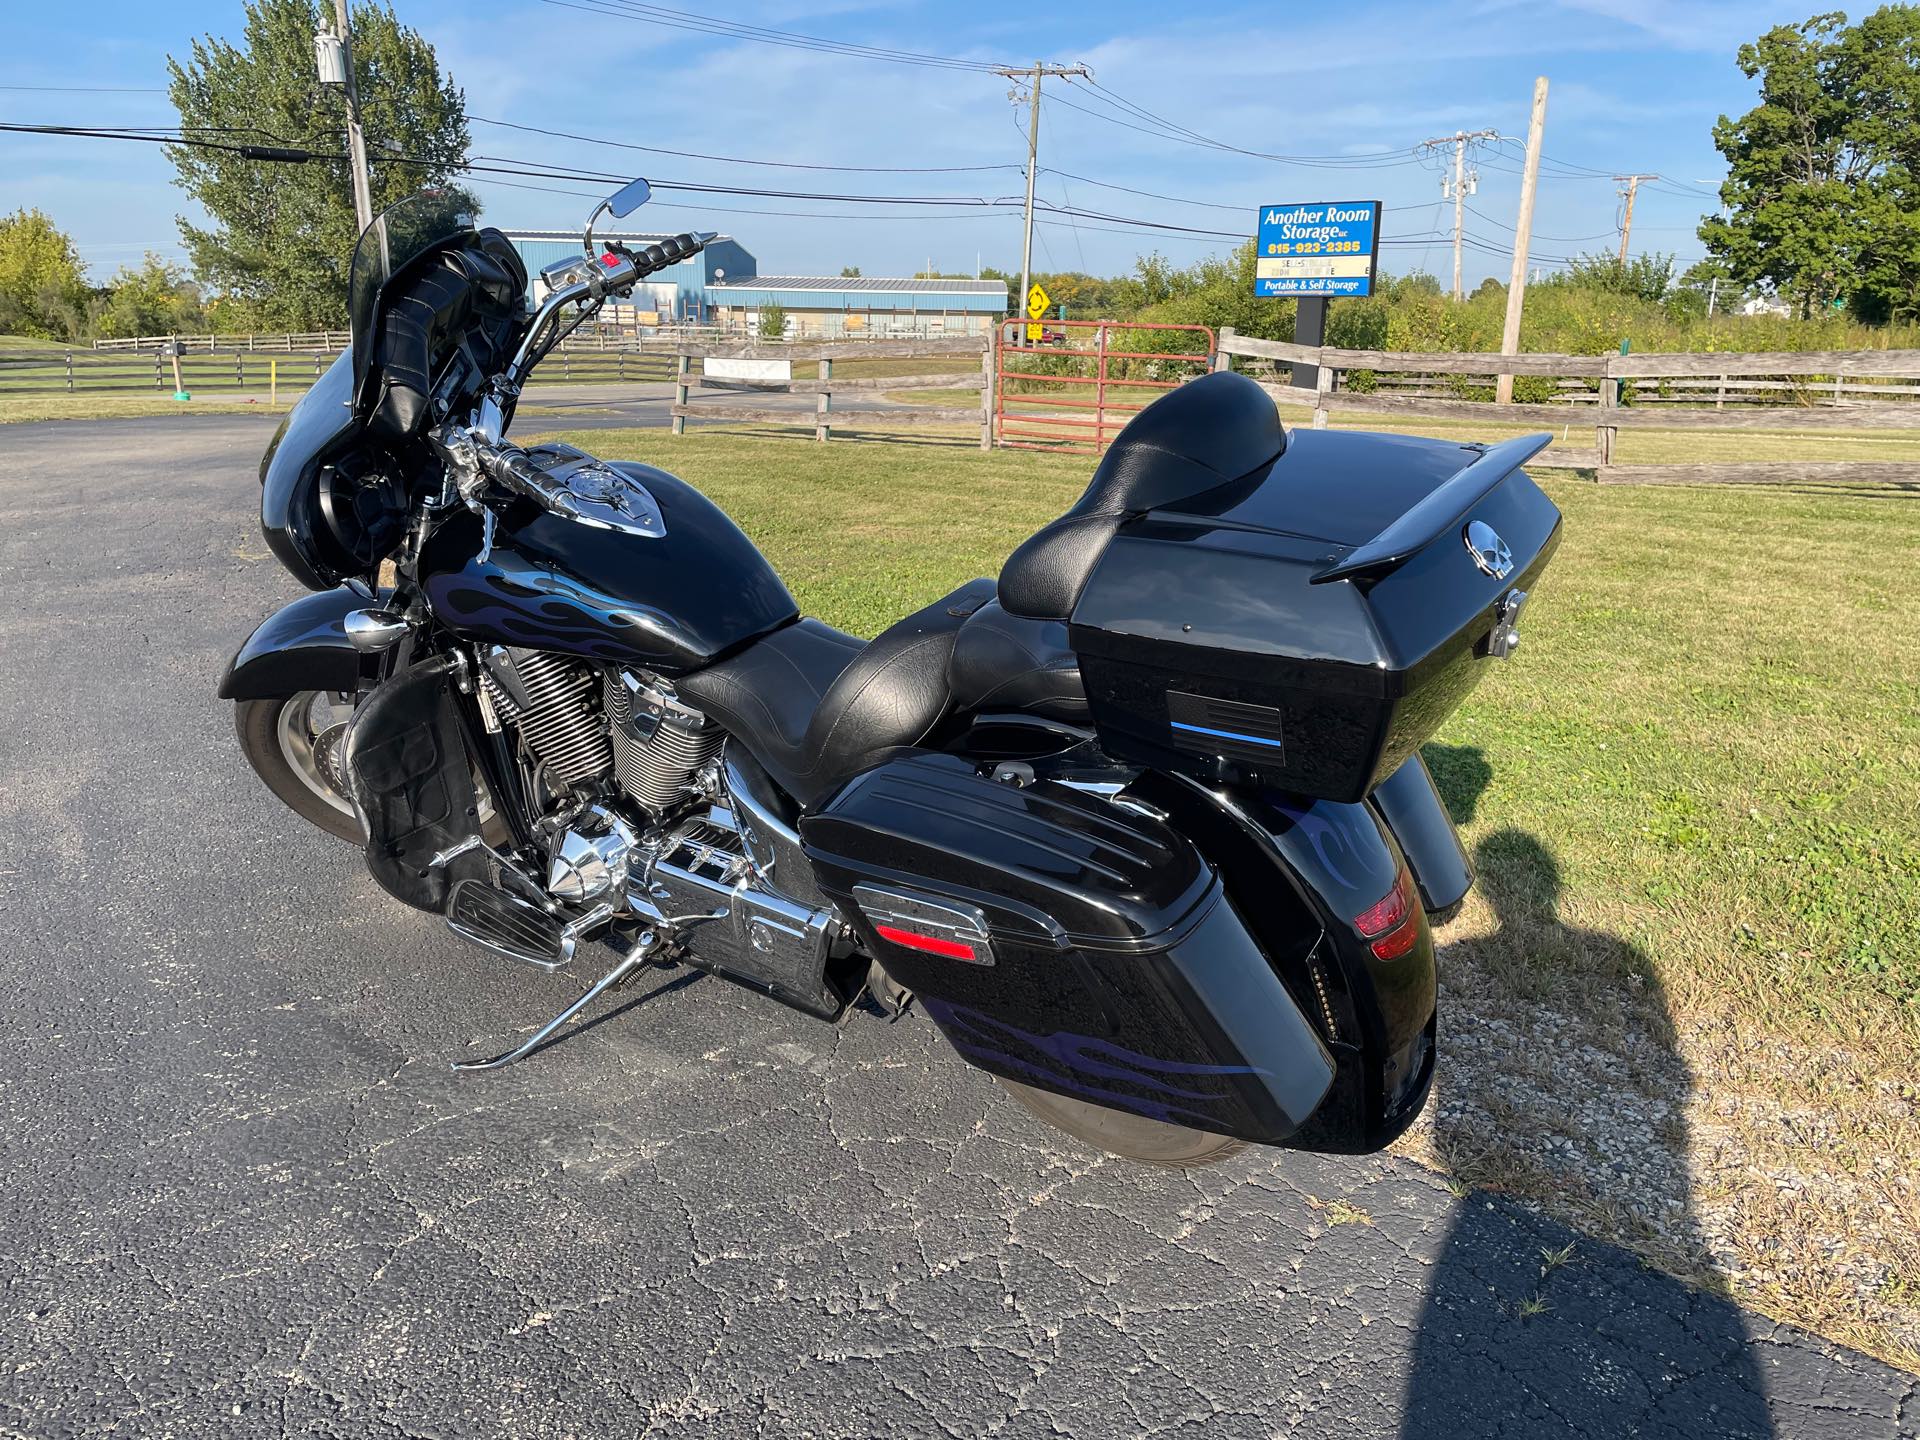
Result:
[420, 445, 799, 674]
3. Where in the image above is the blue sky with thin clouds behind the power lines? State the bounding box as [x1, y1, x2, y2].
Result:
[0, 0, 1789, 286]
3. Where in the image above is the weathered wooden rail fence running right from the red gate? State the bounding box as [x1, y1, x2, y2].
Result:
[1213, 328, 1920, 484]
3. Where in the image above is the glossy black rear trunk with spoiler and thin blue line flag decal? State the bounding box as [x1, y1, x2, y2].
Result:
[1069, 430, 1559, 814]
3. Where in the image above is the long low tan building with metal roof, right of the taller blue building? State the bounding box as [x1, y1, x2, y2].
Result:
[707, 275, 1006, 338]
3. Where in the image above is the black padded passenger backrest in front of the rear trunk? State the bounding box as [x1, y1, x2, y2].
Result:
[998, 371, 1286, 620]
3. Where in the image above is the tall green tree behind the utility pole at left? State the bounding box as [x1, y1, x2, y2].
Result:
[167, 0, 478, 330]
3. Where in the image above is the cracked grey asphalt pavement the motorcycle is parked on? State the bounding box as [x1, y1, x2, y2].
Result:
[0, 417, 1920, 1440]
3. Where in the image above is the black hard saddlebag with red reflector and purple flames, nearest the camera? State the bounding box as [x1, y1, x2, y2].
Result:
[801, 755, 1334, 1144]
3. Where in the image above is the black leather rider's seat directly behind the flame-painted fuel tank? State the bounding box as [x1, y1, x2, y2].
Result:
[674, 580, 993, 804]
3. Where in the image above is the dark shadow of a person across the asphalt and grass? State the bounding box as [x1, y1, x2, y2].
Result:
[1400, 829, 1772, 1440]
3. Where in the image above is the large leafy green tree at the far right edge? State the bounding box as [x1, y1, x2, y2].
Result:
[1699, 6, 1920, 319]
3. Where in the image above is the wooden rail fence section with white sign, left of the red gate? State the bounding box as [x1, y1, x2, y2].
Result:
[672, 336, 993, 449]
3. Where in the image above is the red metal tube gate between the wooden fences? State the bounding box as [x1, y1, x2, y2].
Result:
[993, 321, 1213, 451]
